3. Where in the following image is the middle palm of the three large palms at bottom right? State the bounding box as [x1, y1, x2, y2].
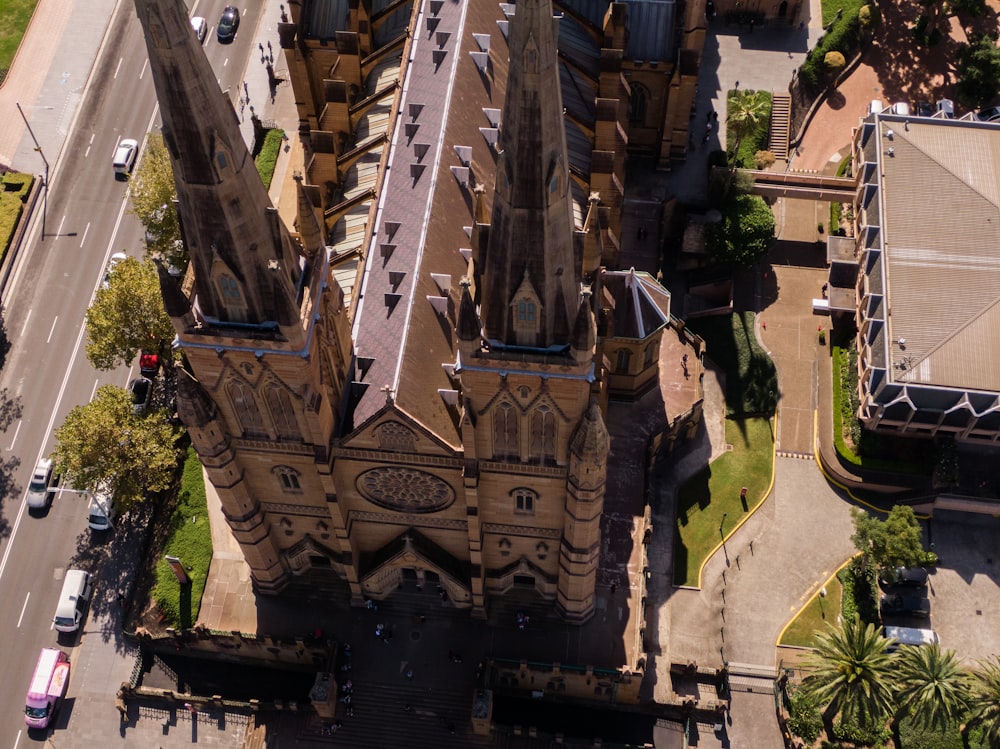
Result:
[893, 643, 969, 731]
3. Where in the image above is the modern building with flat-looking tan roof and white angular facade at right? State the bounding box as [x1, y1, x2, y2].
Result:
[848, 113, 1000, 443]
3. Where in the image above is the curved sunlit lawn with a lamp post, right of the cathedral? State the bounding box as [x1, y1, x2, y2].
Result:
[674, 419, 774, 585]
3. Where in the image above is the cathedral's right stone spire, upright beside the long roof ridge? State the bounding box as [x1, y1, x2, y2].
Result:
[480, 0, 582, 348]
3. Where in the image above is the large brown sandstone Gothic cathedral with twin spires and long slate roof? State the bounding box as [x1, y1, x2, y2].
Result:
[135, 0, 704, 623]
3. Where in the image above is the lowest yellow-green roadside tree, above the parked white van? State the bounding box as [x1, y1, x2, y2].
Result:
[52, 385, 179, 510]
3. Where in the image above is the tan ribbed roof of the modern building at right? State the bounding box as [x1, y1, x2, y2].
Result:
[876, 116, 1000, 391]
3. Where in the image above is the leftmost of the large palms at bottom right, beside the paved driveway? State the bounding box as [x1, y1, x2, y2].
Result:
[802, 617, 894, 729]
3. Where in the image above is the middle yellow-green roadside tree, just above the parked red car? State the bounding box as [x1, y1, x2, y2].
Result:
[86, 257, 174, 370]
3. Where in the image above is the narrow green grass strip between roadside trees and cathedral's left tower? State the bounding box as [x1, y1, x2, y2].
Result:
[153, 448, 212, 628]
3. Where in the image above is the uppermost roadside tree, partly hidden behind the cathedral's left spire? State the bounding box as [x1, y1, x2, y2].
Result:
[131, 133, 186, 267]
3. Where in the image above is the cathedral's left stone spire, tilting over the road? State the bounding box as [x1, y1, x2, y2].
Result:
[135, 0, 300, 334]
